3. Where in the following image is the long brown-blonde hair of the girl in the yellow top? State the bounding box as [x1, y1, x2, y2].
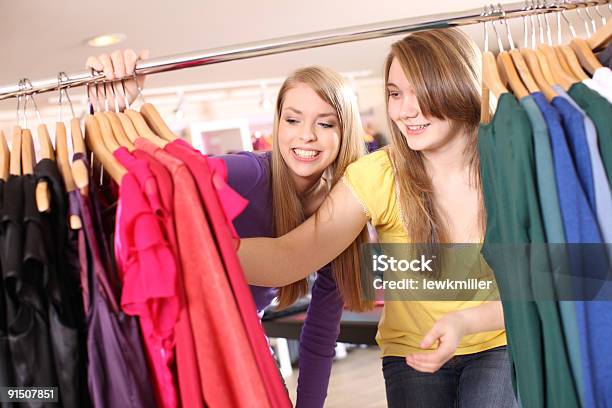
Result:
[385, 29, 485, 244]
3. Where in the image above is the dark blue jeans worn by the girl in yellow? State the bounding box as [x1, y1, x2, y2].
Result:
[383, 346, 518, 408]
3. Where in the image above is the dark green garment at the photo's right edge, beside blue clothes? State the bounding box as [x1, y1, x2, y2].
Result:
[568, 82, 612, 186]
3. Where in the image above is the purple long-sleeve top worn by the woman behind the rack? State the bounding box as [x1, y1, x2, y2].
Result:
[220, 152, 344, 408]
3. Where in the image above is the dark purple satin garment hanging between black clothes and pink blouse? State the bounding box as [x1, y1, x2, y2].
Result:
[74, 154, 156, 408]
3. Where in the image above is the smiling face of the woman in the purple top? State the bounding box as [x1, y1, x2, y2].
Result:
[278, 83, 341, 188]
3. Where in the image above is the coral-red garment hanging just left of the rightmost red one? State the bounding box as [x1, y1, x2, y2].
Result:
[136, 138, 270, 407]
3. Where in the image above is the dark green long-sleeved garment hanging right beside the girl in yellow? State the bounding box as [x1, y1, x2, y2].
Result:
[478, 93, 579, 408]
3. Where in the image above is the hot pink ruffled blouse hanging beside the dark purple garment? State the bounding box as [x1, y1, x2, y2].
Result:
[114, 148, 180, 407]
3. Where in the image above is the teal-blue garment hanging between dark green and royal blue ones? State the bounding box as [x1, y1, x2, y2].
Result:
[520, 95, 583, 399]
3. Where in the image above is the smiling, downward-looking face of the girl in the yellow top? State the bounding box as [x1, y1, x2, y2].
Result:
[387, 58, 457, 151]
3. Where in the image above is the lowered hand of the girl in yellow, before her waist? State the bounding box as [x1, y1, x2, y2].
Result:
[406, 312, 467, 373]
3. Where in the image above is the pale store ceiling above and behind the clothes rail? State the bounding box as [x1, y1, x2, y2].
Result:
[0, 0, 604, 114]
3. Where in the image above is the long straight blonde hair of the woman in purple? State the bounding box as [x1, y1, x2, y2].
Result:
[272, 66, 371, 311]
